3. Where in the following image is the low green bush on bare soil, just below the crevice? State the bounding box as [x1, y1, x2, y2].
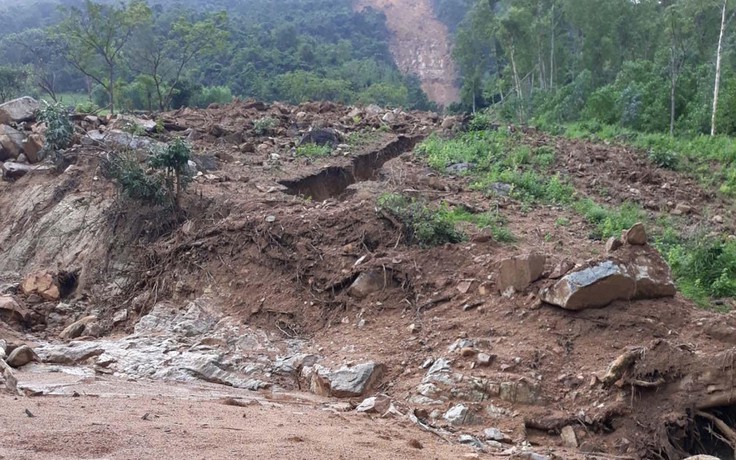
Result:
[378, 193, 464, 248]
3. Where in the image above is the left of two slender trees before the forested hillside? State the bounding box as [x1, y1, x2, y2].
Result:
[57, 0, 152, 113]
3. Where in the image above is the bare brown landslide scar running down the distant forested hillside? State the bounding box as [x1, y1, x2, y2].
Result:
[356, 0, 459, 106]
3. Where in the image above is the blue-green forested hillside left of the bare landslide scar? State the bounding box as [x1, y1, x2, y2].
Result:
[0, 0, 432, 110]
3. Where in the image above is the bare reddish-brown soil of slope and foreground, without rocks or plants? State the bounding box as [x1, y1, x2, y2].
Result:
[0, 102, 736, 460]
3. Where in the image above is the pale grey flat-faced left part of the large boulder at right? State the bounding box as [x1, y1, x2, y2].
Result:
[541, 260, 636, 310]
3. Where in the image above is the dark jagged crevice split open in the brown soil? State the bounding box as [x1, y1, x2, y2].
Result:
[279, 136, 423, 201]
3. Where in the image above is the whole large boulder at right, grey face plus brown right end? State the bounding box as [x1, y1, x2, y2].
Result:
[541, 246, 675, 310]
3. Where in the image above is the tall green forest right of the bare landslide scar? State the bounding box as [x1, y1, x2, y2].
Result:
[452, 0, 736, 134]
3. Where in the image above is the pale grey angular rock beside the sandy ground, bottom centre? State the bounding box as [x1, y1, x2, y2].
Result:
[310, 362, 385, 398]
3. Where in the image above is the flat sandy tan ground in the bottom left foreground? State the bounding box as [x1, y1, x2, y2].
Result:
[0, 373, 478, 460]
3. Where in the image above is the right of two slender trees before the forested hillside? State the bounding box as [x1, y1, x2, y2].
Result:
[129, 12, 229, 111]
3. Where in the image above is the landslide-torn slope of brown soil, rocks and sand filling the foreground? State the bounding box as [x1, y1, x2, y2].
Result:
[0, 95, 736, 460]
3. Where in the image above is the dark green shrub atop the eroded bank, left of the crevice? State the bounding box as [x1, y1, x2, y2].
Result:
[102, 139, 191, 209]
